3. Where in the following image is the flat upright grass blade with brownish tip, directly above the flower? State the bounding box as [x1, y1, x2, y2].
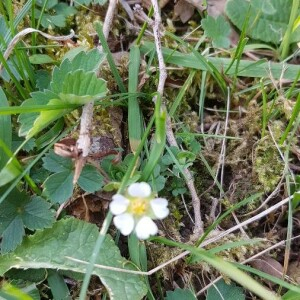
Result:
[128, 45, 142, 153]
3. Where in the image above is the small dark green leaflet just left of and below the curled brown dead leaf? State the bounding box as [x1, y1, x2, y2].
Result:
[42, 150, 73, 173]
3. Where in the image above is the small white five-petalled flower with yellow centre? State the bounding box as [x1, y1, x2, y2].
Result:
[109, 182, 169, 240]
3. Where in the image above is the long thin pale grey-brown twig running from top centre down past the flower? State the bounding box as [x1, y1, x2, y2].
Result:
[151, 0, 203, 240]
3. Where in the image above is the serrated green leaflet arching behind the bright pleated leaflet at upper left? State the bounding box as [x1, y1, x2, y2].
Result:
[50, 49, 105, 93]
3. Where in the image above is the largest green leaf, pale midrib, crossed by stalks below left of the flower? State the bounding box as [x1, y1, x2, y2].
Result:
[0, 218, 147, 300]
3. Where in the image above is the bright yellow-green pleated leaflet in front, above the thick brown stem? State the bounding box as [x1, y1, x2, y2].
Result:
[59, 70, 107, 104]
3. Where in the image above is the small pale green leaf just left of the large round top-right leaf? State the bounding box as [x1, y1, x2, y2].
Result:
[201, 15, 231, 48]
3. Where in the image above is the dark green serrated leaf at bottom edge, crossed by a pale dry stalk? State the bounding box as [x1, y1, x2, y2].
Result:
[206, 279, 246, 300]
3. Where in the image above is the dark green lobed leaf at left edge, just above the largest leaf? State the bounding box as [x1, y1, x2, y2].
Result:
[0, 189, 54, 253]
